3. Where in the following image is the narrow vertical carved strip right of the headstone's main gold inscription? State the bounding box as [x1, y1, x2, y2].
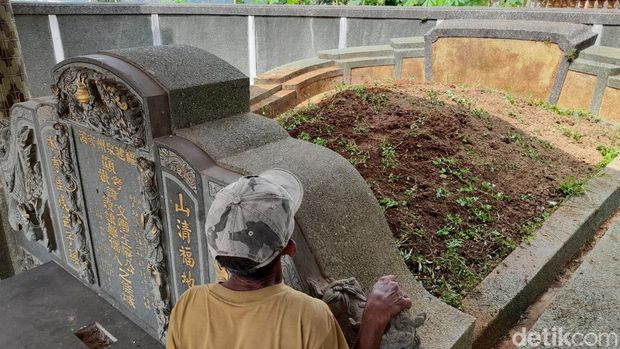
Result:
[138, 157, 171, 342]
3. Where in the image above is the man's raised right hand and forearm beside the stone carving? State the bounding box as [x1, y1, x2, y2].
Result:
[353, 275, 411, 349]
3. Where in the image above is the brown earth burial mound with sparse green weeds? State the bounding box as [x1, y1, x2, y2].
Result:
[280, 82, 618, 307]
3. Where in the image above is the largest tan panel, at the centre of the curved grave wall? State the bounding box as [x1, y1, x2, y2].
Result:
[432, 37, 564, 100]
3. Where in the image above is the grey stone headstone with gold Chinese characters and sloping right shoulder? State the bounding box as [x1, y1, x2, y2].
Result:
[0, 46, 473, 348]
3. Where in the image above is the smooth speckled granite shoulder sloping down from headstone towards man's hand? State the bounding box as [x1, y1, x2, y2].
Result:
[177, 114, 473, 349]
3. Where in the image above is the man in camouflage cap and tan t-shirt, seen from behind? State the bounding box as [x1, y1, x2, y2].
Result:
[167, 170, 411, 349]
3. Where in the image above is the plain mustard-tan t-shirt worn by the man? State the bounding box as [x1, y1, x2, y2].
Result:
[166, 283, 349, 349]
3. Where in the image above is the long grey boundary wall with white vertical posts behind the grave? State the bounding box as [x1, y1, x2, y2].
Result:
[13, 3, 620, 96]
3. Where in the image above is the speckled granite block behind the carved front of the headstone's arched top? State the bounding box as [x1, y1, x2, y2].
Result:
[105, 46, 250, 129]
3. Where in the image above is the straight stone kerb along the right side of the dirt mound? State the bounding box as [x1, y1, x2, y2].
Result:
[463, 159, 620, 348]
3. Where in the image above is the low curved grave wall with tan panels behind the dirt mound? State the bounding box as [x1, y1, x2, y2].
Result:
[250, 20, 620, 123]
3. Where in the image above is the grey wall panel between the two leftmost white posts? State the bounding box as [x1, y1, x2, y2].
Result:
[58, 15, 153, 58]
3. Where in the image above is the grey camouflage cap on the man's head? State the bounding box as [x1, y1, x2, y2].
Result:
[206, 169, 303, 269]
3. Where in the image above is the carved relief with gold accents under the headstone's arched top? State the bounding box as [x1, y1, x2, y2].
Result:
[53, 67, 148, 149]
